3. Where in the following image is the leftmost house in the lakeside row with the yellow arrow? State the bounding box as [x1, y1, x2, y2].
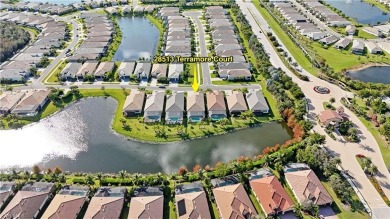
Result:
[122, 89, 145, 116]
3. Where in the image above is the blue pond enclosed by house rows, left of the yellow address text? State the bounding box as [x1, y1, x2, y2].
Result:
[113, 16, 160, 61]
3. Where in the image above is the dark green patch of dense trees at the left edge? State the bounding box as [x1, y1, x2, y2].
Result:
[0, 22, 30, 62]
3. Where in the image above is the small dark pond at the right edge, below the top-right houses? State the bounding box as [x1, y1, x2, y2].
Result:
[348, 66, 390, 84]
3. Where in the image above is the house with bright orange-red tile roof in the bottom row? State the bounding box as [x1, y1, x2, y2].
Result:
[249, 176, 294, 216]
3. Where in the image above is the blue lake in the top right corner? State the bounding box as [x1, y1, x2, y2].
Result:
[324, 0, 390, 24]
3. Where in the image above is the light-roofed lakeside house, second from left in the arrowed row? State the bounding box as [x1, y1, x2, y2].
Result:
[144, 91, 165, 122]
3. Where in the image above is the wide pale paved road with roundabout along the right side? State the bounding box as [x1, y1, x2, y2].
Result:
[236, 0, 390, 208]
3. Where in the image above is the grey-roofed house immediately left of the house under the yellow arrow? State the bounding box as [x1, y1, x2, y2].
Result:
[165, 92, 184, 124]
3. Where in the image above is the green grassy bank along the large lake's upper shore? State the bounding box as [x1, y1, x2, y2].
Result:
[2, 89, 284, 143]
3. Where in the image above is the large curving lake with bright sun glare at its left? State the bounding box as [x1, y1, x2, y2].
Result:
[0, 98, 291, 173]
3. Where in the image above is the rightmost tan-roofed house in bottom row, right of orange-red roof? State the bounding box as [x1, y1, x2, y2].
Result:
[284, 170, 333, 205]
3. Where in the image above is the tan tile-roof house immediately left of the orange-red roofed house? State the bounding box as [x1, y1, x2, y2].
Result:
[213, 183, 257, 219]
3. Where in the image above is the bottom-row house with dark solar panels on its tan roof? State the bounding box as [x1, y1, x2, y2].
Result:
[175, 182, 211, 219]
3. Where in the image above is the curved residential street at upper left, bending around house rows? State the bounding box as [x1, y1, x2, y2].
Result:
[32, 16, 79, 86]
